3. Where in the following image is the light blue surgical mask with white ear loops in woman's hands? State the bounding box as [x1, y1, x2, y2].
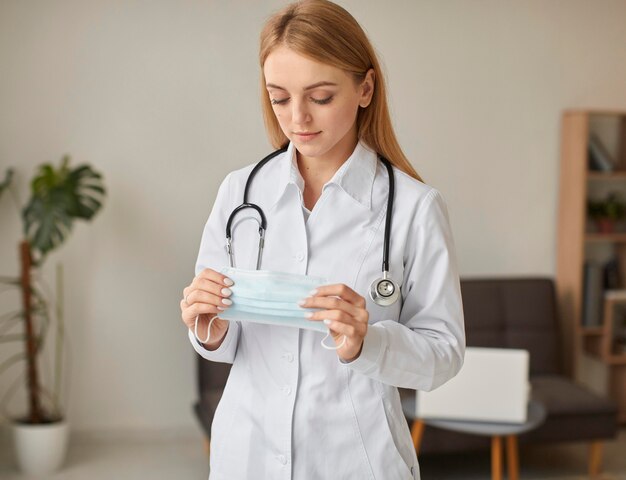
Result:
[195, 267, 346, 350]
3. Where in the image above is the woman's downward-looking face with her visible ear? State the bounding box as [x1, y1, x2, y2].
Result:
[263, 46, 374, 163]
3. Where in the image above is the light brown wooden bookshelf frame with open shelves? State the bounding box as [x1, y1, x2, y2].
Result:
[556, 110, 626, 423]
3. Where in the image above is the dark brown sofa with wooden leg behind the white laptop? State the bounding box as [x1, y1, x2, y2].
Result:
[400, 277, 618, 474]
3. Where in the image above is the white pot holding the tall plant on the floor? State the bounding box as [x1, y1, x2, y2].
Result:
[13, 420, 69, 475]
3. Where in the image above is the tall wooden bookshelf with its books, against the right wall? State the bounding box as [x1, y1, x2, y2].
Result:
[556, 109, 626, 423]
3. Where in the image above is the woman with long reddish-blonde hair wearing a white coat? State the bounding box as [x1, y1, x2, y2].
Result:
[180, 0, 465, 480]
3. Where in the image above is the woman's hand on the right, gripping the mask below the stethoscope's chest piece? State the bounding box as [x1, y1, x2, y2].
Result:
[300, 283, 369, 362]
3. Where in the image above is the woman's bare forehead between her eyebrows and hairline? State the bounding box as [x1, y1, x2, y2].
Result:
[263, 46, 350, 90]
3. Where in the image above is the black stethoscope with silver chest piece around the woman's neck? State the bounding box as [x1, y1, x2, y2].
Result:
[226, 147, 400, 307]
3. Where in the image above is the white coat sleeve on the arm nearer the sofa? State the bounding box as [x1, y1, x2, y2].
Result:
[341, 189, 465, 391]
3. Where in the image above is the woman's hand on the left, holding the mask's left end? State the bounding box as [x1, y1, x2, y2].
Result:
[180, 268, 233, 350]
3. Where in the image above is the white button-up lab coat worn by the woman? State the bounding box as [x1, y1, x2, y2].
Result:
[189, 137, 465, 480]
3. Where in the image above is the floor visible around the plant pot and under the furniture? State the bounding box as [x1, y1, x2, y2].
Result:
[0, 430, 626, 480]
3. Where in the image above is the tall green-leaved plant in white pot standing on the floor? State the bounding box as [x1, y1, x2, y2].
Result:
[0, 155, 105, 475]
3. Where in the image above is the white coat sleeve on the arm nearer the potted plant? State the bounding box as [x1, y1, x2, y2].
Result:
[188, 173, 241, 363]
